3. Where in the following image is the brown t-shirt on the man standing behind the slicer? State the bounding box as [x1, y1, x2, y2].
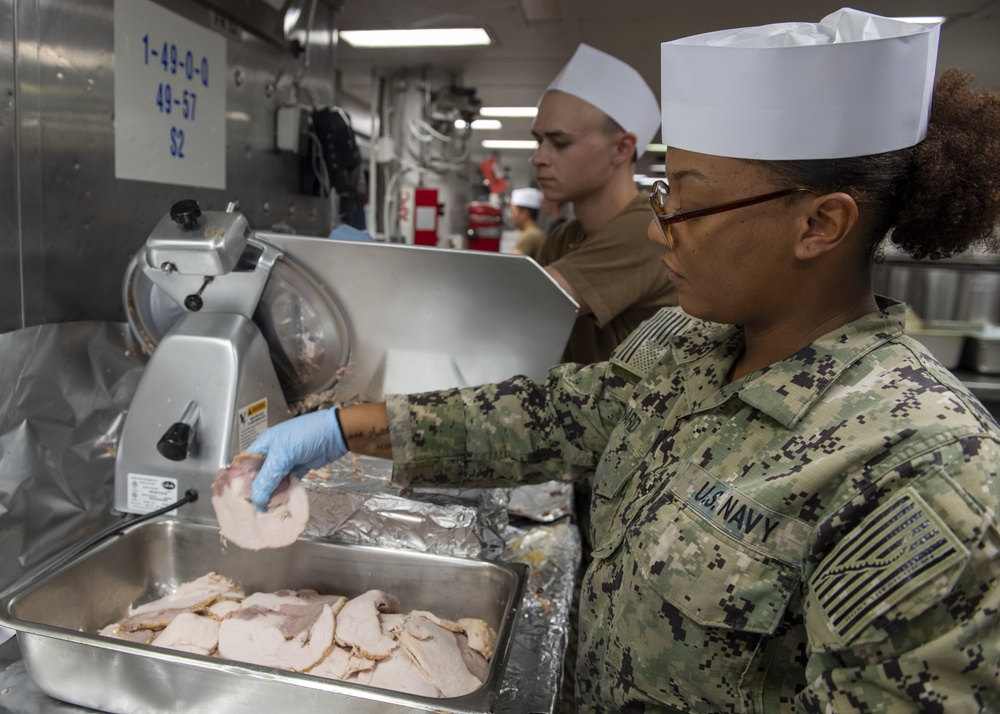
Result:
[536, 193, 677, 364]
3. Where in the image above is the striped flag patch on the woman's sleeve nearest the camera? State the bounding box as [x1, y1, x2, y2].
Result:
[807, 488, 969, 646]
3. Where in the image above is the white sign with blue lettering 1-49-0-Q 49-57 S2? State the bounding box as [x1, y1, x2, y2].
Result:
[115, 0, 226, 188]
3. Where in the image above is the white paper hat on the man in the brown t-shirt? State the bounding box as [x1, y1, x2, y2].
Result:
[545, 44, 660, 156]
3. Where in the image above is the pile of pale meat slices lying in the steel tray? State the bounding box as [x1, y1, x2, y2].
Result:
[100, 572, 496, 697]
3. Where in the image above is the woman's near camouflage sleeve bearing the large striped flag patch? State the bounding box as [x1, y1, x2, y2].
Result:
[799, 438, 1000, 713]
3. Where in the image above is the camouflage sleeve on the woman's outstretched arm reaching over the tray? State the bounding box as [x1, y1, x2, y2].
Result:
[386, 363, 632, 487]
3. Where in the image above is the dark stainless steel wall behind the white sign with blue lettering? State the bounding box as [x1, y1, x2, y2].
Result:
[0, 0, 342, 331]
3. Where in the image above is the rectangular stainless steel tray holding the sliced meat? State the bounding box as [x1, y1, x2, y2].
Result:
[0, 519, 527, 714]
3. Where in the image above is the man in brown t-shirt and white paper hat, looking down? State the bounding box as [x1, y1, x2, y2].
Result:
[531, 44, 677, 364]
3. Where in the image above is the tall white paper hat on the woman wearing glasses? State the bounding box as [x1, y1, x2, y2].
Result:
[661, 8, 940, 160]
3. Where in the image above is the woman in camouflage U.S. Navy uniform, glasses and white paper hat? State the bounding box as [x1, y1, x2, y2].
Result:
[250, 9, 1000, 714]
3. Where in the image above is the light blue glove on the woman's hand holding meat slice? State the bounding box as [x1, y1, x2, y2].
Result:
[247, 407, 347, 511]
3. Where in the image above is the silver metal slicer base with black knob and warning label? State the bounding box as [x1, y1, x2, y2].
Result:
[115, 313, 288, 523]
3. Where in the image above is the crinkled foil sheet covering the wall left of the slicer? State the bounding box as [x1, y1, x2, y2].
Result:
[0, 322, 145, 590]
